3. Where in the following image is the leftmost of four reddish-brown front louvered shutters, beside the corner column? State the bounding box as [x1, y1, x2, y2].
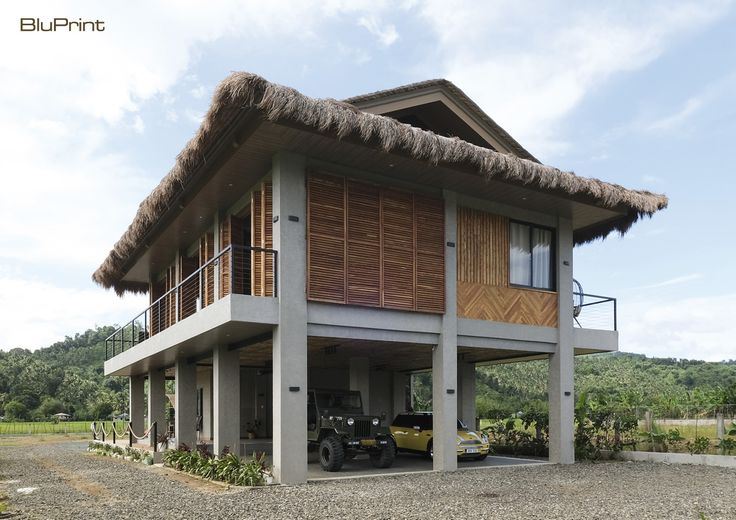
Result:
[307, 175, 346, 303]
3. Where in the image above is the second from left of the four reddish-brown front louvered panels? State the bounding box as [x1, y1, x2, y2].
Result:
[347, 181, 381, 307]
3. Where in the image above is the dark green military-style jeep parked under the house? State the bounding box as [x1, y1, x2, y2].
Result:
[307, 389, 396, 471]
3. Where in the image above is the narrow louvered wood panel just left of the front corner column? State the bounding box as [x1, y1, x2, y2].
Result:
[251, 182, 274, 296]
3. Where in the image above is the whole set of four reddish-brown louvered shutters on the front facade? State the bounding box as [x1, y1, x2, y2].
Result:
[307, 173, 445, 313]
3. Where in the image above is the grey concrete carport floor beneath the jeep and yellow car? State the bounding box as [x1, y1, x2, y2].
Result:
[307, 452, 548, 481]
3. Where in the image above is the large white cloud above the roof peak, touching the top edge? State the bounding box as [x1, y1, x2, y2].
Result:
[420, 0, 730, 155]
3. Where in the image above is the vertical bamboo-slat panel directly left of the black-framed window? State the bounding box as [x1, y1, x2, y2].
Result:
[457, 207, 509, 287]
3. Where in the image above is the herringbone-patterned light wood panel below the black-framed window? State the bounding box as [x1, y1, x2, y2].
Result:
[457, 282, 558, 327]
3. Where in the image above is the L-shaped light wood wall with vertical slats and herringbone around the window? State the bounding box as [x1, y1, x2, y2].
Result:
[457, 207, 558, 327]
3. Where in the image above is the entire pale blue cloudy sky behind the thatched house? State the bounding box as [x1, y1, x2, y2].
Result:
[0, 0, 736, 360]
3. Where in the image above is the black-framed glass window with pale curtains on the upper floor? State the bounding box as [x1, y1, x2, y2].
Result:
[509, 222, 555, 291]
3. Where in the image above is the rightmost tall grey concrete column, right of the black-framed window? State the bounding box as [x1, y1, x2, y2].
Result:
[548, 217, 575, 464]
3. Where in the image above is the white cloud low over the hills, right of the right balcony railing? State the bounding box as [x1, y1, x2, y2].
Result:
[619, 294, 736, 361]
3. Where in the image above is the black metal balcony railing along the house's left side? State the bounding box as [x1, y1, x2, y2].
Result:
[105, 246, 278, 359]
